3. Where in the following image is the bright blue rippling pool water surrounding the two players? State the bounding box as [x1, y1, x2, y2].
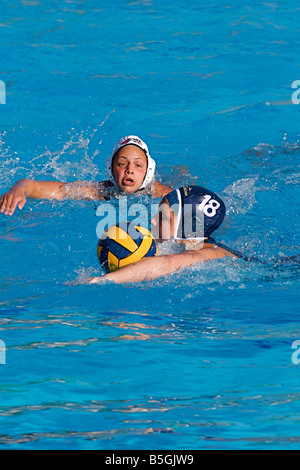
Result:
[0, 0, 300, 450]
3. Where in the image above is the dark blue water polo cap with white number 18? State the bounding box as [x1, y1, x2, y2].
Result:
[162, 186, 226, 240]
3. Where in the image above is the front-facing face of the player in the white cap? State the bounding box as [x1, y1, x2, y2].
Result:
[113, 145, 147, 193]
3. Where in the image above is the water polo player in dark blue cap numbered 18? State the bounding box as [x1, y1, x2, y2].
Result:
[88, 186, 237, 284]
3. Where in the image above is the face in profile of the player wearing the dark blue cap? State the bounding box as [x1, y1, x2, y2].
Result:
[150, 199, 176, 243]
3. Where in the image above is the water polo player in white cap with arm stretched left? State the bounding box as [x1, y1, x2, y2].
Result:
[0, 135, 172, 215]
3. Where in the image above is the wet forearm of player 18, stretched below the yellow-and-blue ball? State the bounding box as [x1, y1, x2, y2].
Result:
[88, 246, 235, 284]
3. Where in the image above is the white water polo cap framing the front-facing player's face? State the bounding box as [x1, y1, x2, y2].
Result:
[106, 135, 155, 190]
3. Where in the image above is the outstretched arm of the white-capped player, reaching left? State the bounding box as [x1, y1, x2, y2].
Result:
[0, 178, 103, 215]
